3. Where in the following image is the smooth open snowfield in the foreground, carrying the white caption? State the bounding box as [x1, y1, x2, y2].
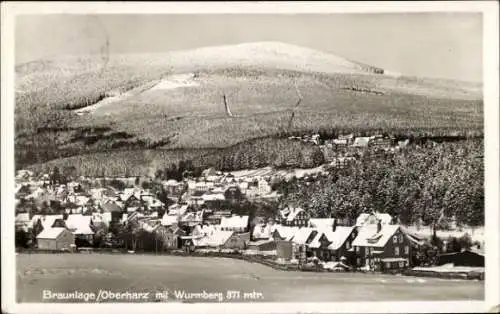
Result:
[16, 253, 484, 302]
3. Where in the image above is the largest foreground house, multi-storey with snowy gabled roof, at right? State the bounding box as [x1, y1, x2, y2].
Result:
[352, 222, 412, 270]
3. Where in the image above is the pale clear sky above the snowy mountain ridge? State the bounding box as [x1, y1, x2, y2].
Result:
[15, 13, 483, 82]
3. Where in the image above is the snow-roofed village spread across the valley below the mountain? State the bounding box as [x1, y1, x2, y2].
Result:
[15, 135, 484, 271]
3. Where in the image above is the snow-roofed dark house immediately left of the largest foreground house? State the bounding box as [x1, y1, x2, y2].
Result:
[308, 225, 356, 262]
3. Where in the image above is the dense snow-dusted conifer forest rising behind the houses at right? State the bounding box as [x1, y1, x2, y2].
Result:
[277, 141, 484, 229]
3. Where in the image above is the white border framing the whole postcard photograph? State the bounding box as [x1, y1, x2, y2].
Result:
[1, 1, 500, 314]
